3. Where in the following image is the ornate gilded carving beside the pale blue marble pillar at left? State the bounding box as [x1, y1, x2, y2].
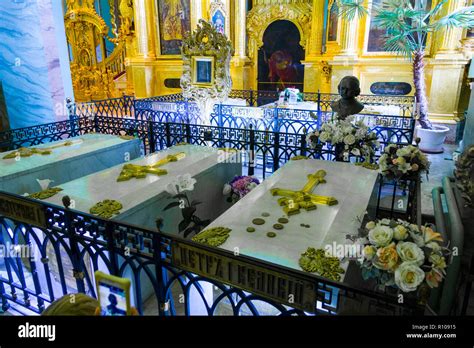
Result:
[64, 0, 134, 101]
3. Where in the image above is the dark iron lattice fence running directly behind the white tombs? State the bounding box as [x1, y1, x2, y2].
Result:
[0, 111, 413, 184]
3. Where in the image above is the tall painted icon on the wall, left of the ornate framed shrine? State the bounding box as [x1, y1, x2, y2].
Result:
[158, 0, 191, 54]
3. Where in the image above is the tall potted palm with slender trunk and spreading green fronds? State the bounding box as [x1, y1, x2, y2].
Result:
[337, 0, 474, 129]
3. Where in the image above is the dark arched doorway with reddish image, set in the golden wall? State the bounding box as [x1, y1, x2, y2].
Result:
[257, 20, 305, 91]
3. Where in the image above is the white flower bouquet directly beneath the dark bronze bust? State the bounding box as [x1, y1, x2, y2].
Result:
[306, 117, 380, 162]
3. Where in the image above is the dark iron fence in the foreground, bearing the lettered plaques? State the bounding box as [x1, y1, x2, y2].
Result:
[0, 192, 422, 315]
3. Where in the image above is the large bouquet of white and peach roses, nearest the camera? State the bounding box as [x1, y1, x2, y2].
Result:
[357, 219, 449, 292]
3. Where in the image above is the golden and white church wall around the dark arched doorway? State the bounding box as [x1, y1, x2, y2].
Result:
[109, 0, 472, 123]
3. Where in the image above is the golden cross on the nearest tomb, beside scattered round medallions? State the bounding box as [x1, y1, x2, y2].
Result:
[270, 170, 338, 215]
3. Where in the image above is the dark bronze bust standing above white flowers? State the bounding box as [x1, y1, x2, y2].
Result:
[331, 76, 364, 120]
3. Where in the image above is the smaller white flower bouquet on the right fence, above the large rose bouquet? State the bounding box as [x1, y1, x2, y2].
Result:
[379, 144, 430, 179]
